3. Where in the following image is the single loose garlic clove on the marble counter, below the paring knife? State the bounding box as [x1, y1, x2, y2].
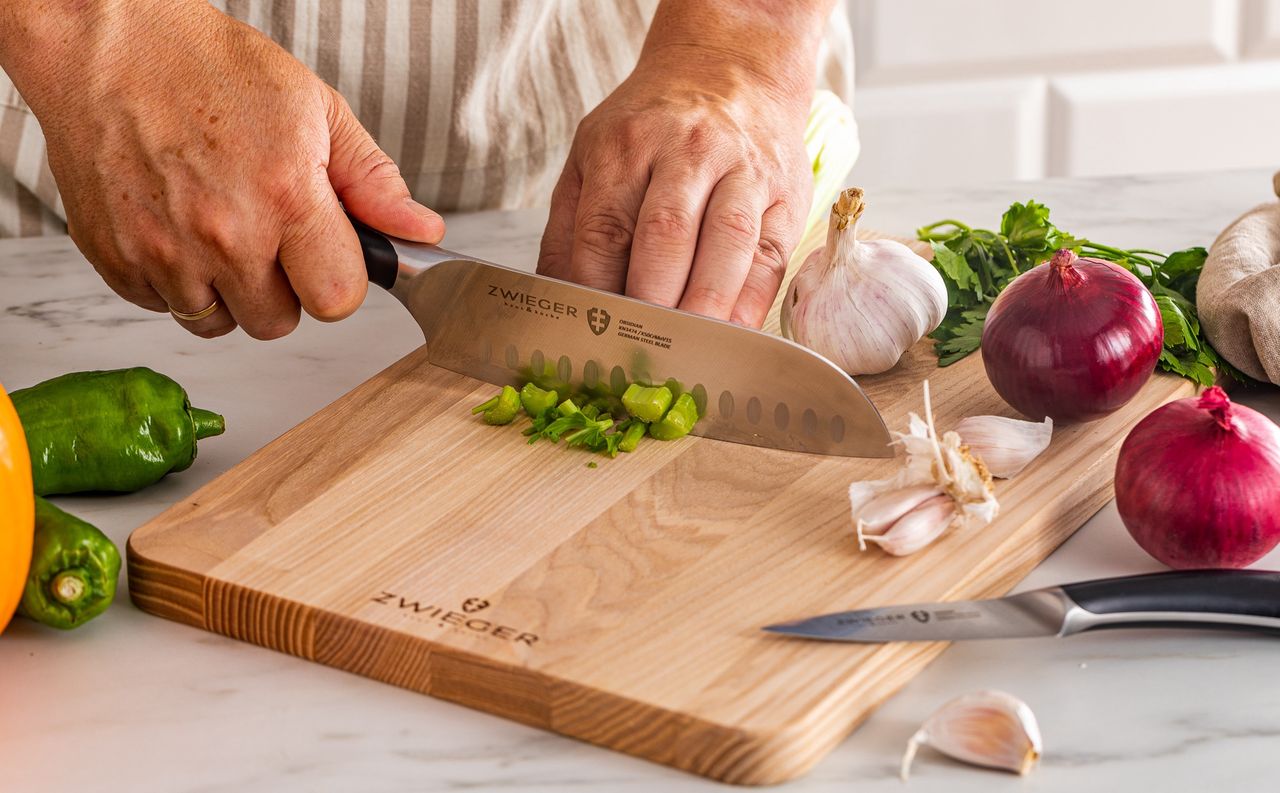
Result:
[901, 691, 1042, 781]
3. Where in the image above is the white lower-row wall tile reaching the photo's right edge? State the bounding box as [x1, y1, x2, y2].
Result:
[1050, 61, 1280, 177]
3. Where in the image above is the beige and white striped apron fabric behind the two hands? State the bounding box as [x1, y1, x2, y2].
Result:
[0, 0, 852, 237]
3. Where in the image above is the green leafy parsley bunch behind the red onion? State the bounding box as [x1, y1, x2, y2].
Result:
[916, 201, 1244, 385]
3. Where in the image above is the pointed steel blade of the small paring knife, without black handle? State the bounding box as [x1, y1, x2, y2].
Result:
[764, 587, 1078, 642]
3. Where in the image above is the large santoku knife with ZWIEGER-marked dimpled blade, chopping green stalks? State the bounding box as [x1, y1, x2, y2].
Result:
[351, 219, 892, 457]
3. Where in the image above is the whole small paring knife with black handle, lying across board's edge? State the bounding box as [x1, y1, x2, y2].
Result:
[764, 570, 1280, 643]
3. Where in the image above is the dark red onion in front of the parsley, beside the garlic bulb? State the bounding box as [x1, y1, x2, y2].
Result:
[982, 249, 1165, 422]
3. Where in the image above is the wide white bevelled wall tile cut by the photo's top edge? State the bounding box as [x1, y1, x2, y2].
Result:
[852, 0, 1240, 84]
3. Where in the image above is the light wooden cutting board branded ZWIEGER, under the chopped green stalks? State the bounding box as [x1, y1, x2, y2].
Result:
[128, 250, 1192, 784]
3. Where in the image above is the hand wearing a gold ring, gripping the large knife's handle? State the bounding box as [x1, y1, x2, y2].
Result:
[14, 0, 444, 339]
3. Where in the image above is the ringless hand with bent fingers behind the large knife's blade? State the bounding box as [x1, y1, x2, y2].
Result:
[538, 47, 813, 327]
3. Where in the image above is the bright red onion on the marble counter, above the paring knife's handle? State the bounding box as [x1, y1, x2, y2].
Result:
[1116, 386, 1280, 569]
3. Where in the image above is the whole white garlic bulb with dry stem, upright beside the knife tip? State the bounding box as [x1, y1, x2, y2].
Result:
[781, 187, 947, 375]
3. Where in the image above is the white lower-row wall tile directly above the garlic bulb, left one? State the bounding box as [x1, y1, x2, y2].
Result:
[851, 79, 1047, 188]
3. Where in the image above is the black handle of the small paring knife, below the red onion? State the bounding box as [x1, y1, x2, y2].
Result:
[1061, 570, 1280, 634]
